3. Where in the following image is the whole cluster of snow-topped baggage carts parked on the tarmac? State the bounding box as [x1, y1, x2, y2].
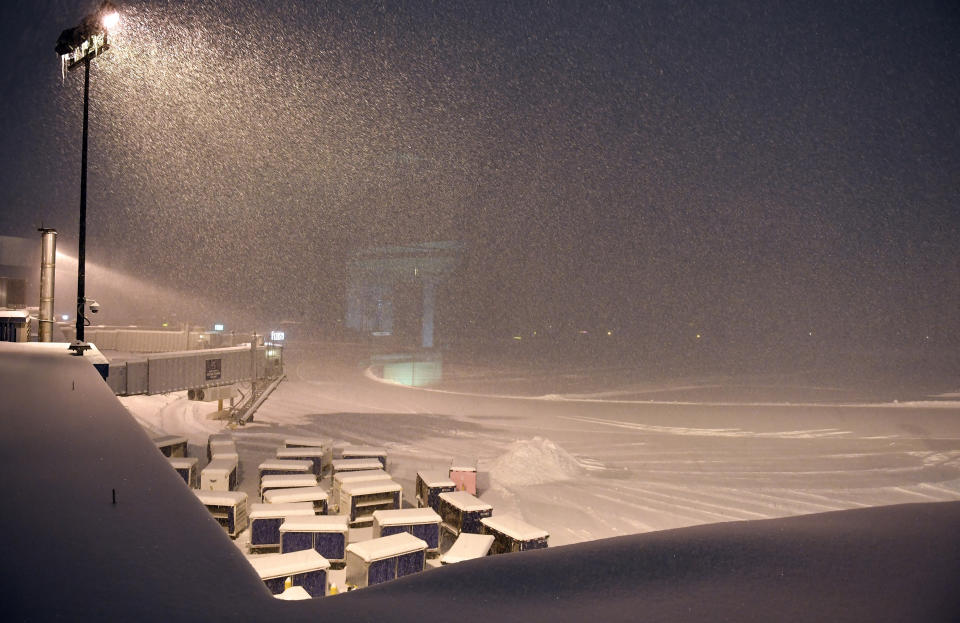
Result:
[155, 435, 549, 598]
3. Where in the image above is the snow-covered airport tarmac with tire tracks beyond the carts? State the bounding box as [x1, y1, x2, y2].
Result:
[122, 343, 960, 545]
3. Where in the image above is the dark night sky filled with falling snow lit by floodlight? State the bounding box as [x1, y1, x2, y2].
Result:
[0, 0, 960, 366]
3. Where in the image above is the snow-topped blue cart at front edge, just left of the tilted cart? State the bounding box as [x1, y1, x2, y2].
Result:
[347, 532, 427, 588]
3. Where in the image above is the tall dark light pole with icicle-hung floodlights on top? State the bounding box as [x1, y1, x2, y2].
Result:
[56, 0, 120, 355]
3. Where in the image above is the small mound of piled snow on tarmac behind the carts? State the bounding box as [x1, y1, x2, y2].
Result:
[489, 437, 584, 485]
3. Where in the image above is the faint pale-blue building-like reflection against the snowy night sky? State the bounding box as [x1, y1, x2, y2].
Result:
[347, 242, 462, 348]
